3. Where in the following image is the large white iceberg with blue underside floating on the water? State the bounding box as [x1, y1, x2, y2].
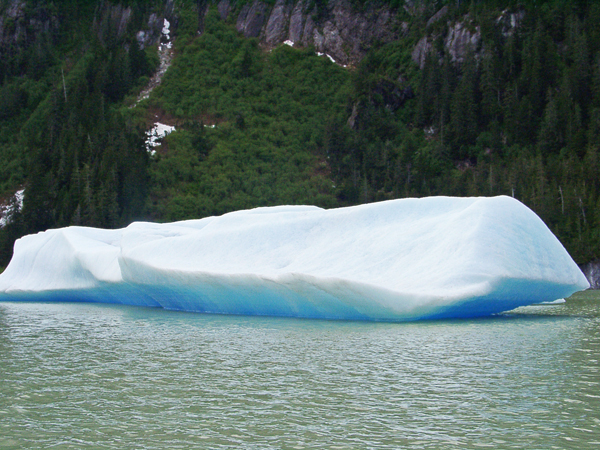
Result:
[0, 197, 589, 321]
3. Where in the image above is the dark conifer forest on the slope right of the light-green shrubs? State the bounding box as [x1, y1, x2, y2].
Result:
[346, 1, 600, 262]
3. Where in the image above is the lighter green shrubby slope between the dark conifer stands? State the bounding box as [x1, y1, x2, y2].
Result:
[146, 12, 350, 220]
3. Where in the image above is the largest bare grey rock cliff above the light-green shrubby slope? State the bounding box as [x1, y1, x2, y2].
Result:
[204, 0, 408, 65]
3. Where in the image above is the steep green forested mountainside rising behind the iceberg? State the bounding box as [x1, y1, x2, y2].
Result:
[0, 0, 600, 266]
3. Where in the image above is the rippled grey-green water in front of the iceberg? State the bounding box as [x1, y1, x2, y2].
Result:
[0, 292, 600, 449]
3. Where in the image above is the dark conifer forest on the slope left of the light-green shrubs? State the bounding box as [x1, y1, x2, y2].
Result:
[0, 1, 159, 264]
